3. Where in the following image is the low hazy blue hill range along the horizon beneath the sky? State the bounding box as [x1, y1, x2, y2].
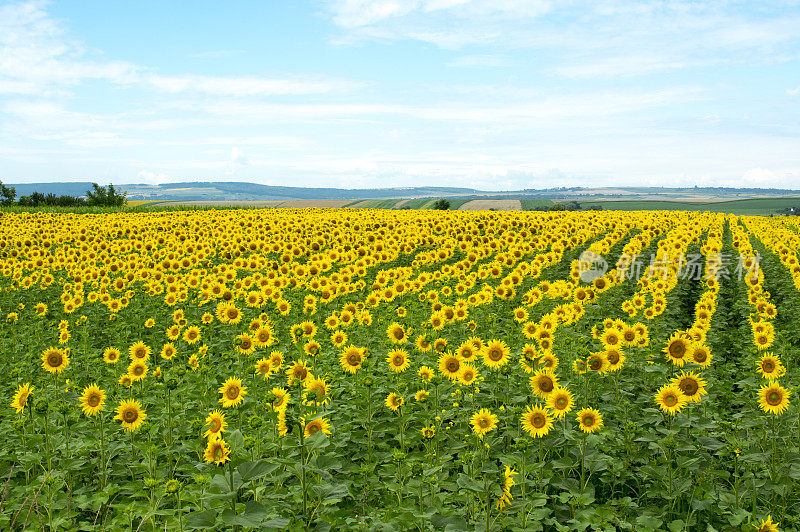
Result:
[7, 181, 800, 202]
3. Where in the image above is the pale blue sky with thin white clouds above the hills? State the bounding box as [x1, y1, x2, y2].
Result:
[0, 0, 800, 190]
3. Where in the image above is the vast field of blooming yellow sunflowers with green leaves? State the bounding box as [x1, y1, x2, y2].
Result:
[0, 209, 800, 532]
